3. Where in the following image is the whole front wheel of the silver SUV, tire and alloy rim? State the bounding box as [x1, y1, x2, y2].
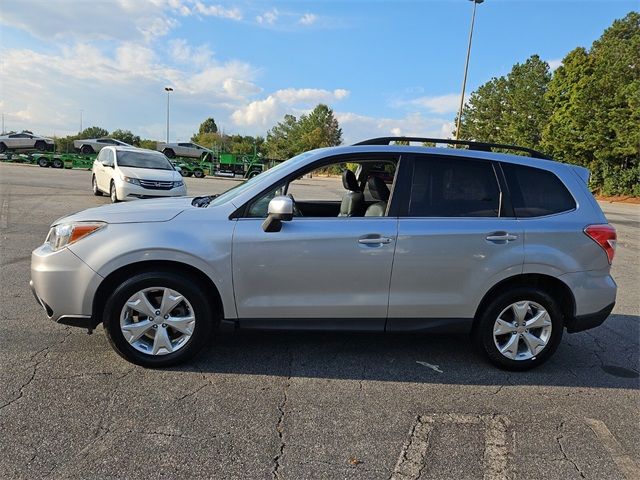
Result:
[103, 271, 213, 368]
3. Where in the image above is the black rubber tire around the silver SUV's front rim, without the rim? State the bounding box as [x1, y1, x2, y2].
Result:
[102, 271, 217, 368]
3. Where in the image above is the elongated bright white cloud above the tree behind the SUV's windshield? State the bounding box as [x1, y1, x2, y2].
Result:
[231, 88, 349, 128]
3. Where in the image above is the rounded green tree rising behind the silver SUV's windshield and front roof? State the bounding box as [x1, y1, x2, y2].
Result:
[265, 104, 342, 159]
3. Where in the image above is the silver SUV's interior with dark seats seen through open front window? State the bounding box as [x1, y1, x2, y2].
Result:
[246, 159, 397, 218]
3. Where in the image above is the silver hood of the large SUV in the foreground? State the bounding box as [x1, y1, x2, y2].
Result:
[52, 197, 195, 225]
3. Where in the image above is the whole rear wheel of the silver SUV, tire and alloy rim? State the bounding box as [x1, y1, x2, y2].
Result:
[473, 287, 564, 370]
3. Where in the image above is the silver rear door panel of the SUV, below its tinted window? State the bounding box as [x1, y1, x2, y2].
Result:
[389, 218, 524, 324]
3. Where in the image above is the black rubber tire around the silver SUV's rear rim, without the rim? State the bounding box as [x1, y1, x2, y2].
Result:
[472, 287, 564, 371]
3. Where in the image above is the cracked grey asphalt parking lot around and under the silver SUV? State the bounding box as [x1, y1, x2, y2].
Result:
[0, 164, 640, 480]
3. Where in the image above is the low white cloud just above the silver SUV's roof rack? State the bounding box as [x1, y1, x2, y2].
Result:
[336, 112, 453, 145]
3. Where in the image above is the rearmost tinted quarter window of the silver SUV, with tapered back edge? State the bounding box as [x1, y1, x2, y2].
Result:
[502, 163, 576, 218]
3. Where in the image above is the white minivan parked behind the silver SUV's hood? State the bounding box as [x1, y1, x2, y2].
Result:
[91, 146, 187, 203]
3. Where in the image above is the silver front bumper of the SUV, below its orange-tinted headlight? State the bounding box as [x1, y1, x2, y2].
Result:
[30, 245, 102, 328]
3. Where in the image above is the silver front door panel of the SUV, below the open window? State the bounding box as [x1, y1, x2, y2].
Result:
[233, 217, 397, 330]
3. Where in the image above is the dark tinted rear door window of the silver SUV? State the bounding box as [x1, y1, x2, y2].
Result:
[408, 158, 500, 217]
